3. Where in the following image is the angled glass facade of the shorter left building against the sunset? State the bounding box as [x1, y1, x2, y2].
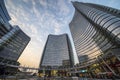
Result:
[0, 26, 30, 61]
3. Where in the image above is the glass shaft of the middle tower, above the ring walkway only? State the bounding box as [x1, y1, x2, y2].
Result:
[40, 34, 74, 67]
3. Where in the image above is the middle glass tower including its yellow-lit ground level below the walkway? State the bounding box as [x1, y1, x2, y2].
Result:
[39, 34, 74, 76]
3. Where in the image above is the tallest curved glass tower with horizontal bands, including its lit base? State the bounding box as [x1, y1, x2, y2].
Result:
[69, 2, 120, 75]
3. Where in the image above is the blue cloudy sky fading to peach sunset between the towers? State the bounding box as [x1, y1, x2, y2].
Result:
[5, 0, 120, 68]
